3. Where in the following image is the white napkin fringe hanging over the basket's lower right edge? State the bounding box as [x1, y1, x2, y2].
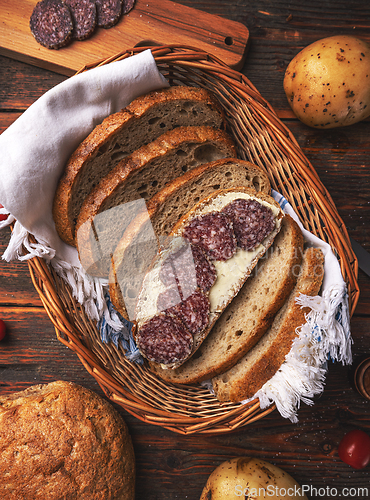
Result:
[248, 285, 352, 423]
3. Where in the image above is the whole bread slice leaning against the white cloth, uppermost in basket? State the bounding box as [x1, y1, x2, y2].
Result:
[53, 86, 223, 245]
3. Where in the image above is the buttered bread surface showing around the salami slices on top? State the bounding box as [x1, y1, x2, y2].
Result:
[135, 186, 284, 369]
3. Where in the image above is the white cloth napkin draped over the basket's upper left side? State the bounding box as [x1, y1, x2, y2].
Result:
[0, 50, 168, 267]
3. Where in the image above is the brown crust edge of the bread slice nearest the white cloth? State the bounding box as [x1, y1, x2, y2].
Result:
[53, 86, 224, 246]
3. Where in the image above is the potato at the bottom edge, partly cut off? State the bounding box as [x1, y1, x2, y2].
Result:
[200, 457, 307, 500]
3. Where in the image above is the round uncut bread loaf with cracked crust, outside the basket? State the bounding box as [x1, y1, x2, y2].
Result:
[0, 381, 135, 500]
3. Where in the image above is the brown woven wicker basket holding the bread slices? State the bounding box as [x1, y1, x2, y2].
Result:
[28, 45, 359, 434]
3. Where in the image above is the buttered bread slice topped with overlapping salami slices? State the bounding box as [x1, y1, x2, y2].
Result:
[135, 186, 284, 369]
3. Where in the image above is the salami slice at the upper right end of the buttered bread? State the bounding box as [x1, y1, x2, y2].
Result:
[222, 198, 275, 250]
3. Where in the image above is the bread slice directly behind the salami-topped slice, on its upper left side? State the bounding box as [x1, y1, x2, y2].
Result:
[110, 158, 271, 319]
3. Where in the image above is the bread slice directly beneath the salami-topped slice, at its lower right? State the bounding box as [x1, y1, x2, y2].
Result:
[151, 215, 303, 384]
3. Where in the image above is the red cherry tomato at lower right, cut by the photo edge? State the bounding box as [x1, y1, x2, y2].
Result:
[338, 429, 370, 469]
